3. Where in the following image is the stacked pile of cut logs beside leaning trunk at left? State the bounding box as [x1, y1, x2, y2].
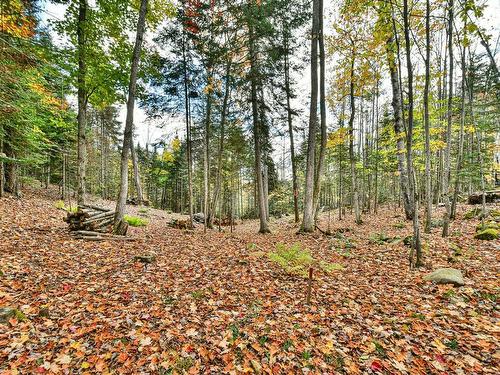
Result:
[64, 205, 127, 241]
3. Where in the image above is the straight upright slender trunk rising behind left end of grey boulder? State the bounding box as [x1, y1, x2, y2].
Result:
[424, 0, 432, 233]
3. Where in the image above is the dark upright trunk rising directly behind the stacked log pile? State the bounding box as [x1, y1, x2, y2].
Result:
[77, 0, 87, 205]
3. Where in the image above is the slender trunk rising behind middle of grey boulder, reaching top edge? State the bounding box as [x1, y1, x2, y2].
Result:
[442, 0, 453, 237]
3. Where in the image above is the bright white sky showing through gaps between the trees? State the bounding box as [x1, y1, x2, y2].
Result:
[40, 0, 500, 160]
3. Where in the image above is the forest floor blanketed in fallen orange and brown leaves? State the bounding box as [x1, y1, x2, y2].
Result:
[0, 189, 500, 374]
